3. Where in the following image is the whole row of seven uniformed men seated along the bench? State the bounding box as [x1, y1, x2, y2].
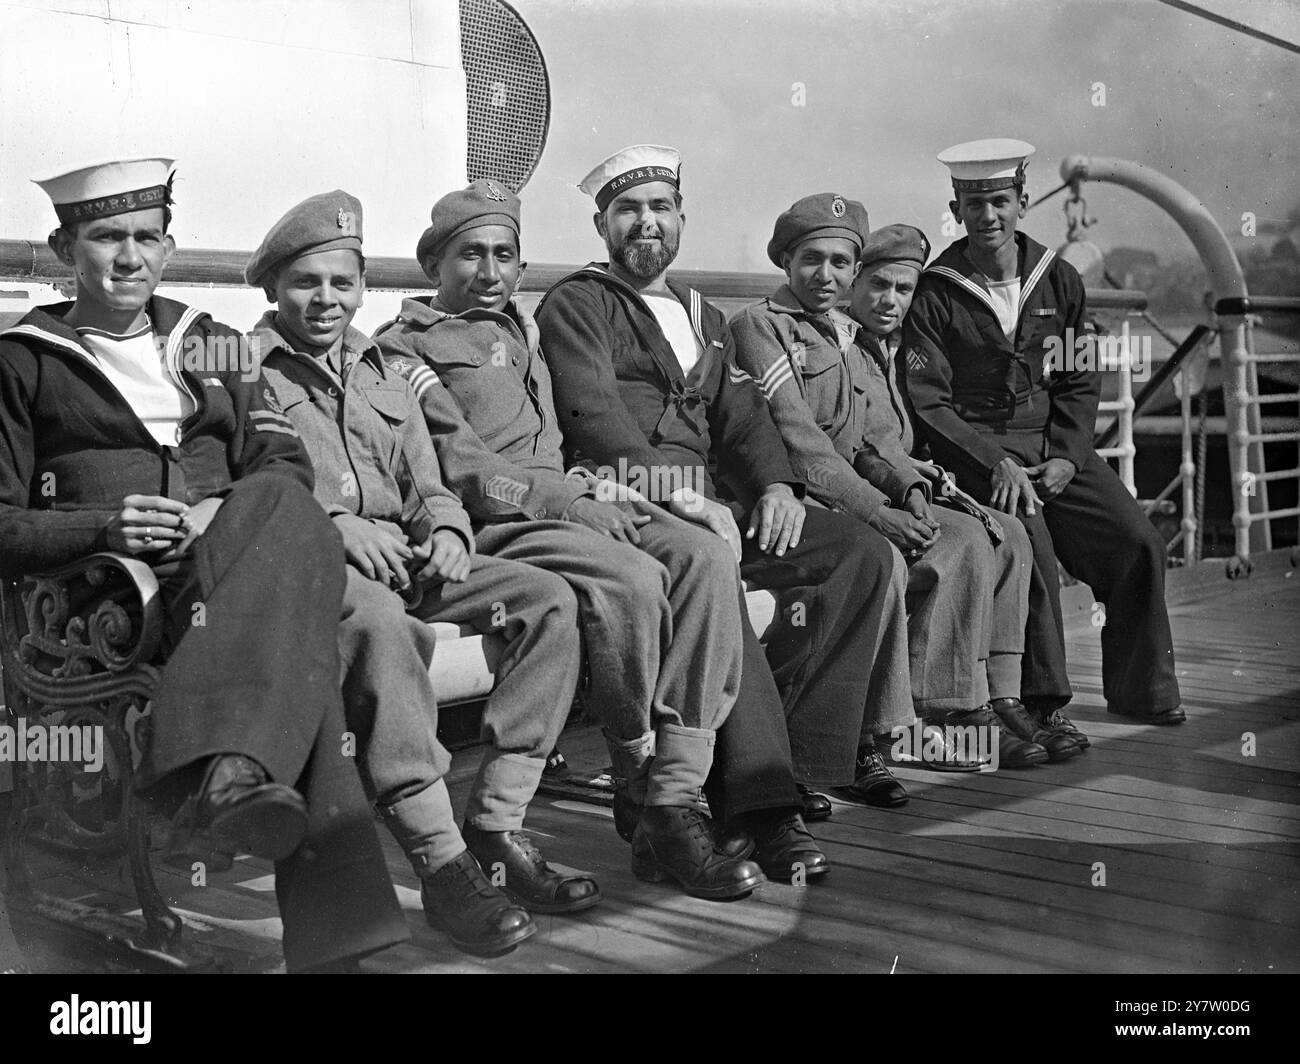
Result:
[0, 140, 1183, 972]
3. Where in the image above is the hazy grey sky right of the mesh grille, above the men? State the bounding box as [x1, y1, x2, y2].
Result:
[514, 0, 1300, 271]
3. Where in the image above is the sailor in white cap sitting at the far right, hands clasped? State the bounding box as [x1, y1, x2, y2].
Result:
[904, 139, 1184, 728]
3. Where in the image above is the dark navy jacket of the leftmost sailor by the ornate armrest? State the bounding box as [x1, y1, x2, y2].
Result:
[0, 297, 313, 576]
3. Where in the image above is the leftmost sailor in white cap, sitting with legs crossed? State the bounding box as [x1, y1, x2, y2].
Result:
[0, 156, 407, 970]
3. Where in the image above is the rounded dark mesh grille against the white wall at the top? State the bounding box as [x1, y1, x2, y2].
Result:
[460, 0, 551, 193]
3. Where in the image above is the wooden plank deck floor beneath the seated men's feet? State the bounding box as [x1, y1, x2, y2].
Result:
[0, 553, 1300, 973]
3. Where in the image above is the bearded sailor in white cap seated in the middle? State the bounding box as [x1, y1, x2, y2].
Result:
[537, 144, 913, 848]
